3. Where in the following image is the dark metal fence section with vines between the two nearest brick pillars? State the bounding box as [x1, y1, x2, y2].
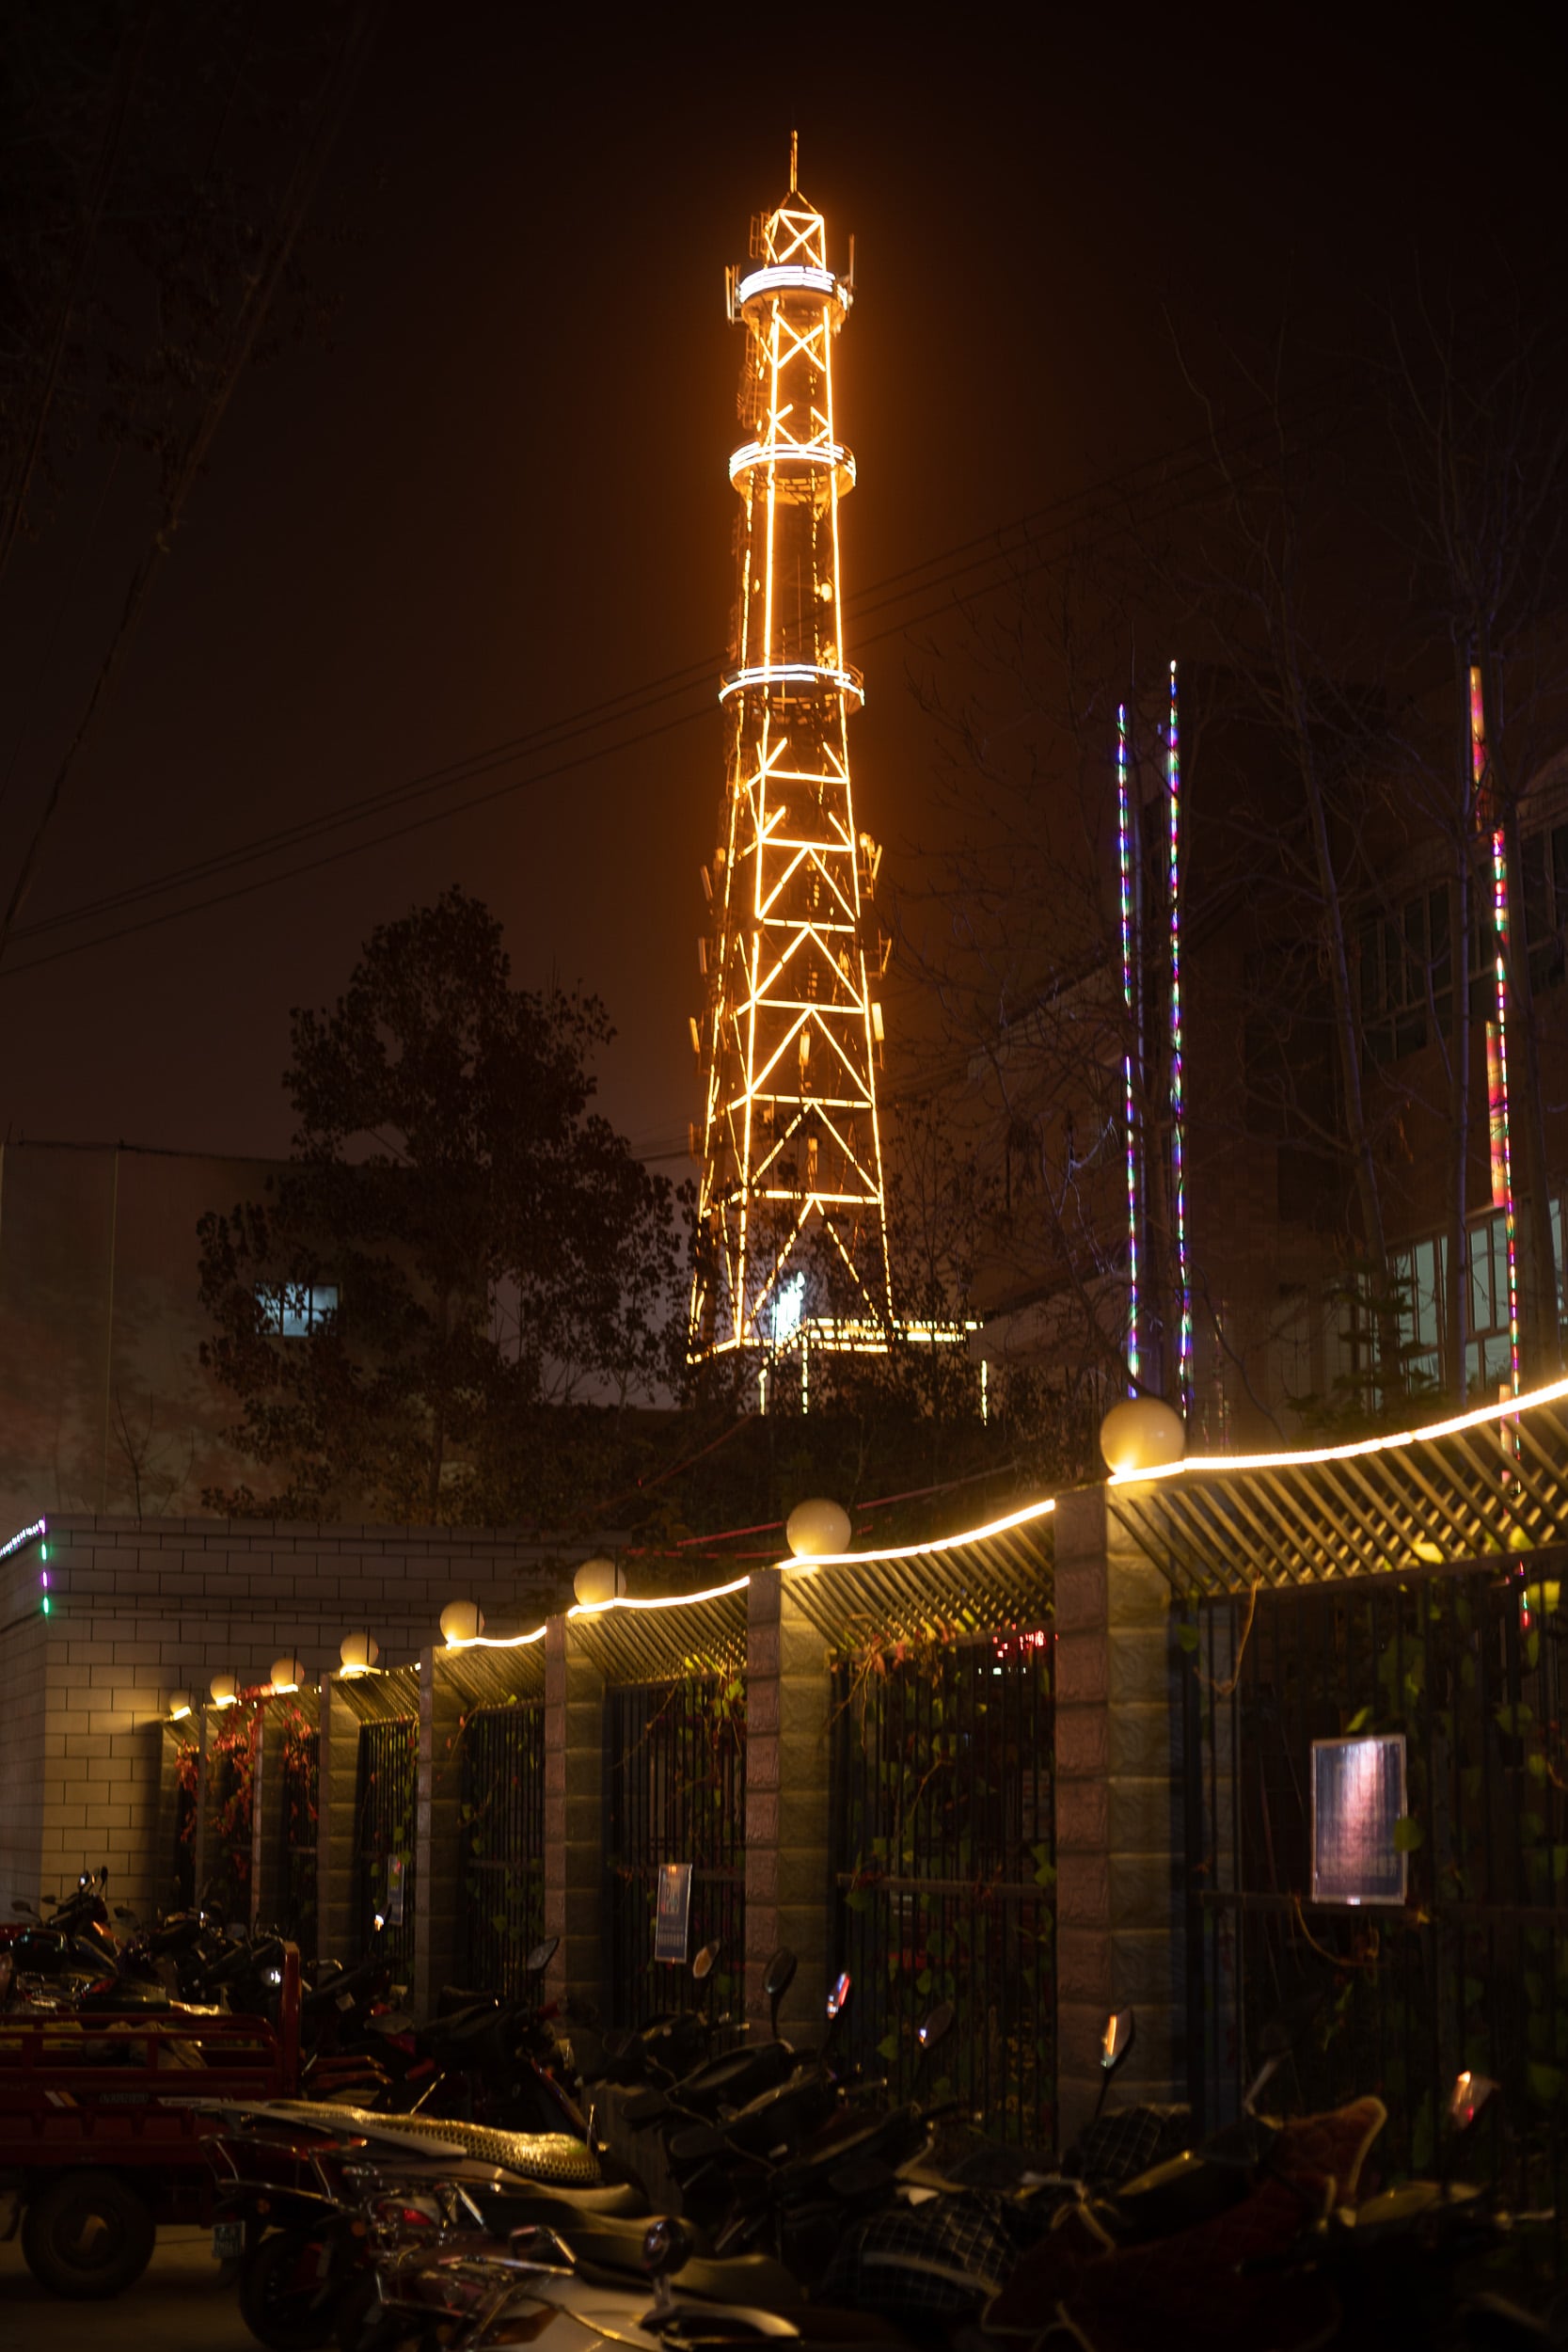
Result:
[832, 1630, 1055, 2150]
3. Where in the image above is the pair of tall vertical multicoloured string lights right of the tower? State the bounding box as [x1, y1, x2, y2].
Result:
[1117, 663, 1192, 1423]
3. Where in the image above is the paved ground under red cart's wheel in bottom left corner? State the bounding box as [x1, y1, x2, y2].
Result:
[0, 2230, 256, 2352]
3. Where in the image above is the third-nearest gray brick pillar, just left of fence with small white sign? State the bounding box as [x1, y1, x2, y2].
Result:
[546, 1616, 611, 2016]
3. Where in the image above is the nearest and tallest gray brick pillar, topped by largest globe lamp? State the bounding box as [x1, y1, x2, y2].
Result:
[1055, 1486, 1187, 2145]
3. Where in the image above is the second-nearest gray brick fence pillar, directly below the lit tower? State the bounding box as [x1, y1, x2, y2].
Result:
[745, 1569, 832, 2044]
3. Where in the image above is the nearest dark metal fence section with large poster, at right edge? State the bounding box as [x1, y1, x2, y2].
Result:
[1182, 1560, 1568, 2258]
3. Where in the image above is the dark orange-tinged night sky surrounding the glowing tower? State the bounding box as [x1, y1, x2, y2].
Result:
[0, 5, 1561, 1174]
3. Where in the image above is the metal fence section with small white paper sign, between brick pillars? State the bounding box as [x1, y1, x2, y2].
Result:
[604, 1675, 745, 2026]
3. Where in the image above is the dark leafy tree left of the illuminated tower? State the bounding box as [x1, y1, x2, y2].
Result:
[199, 889, 679, 1524]
